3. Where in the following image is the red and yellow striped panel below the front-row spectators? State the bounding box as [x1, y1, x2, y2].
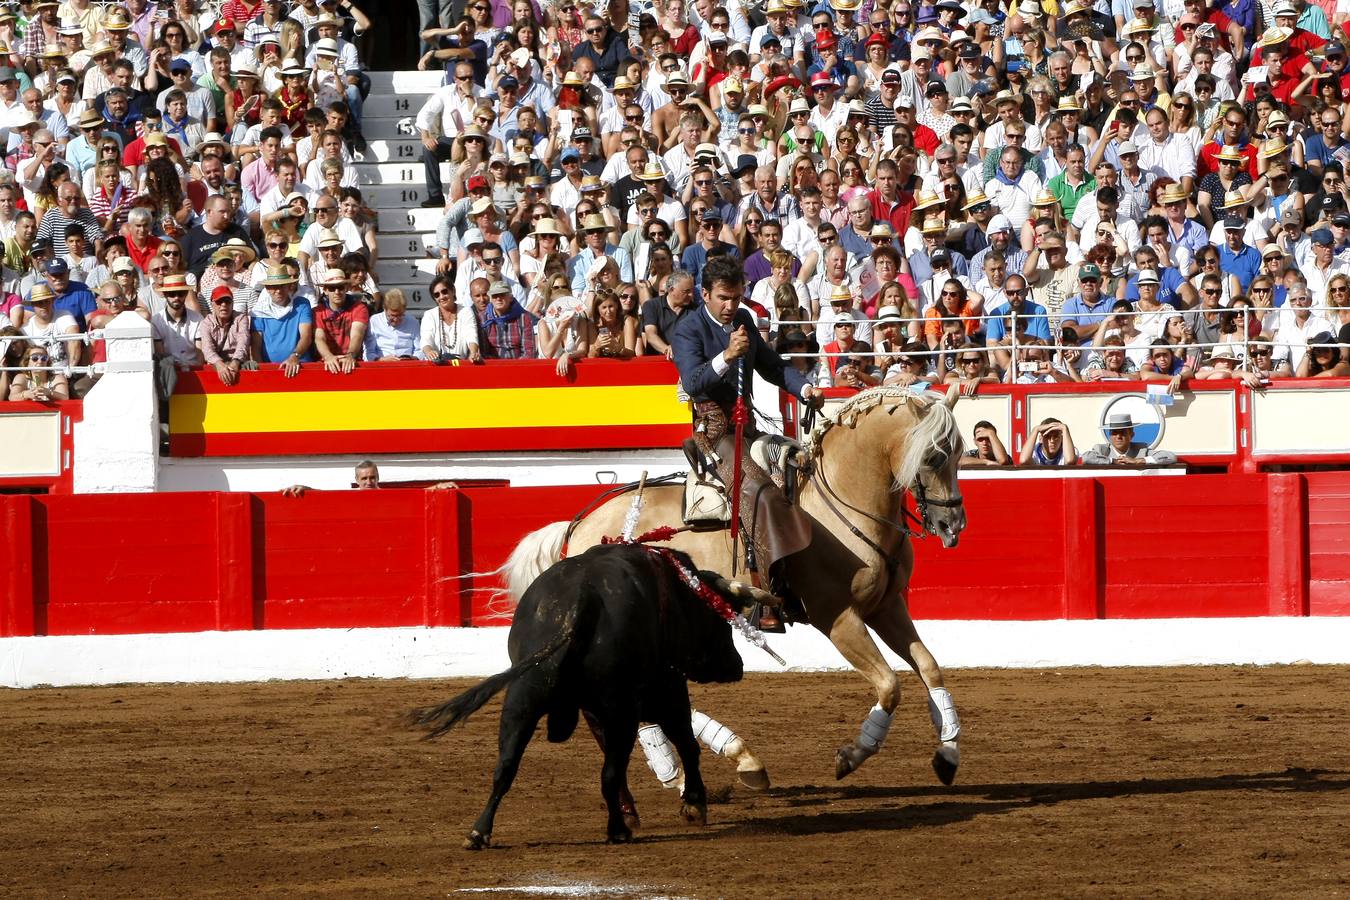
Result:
[169, 359, 690, 456]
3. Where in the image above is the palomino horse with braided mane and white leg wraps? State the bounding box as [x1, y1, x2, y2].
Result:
[504, 387, 965, 784]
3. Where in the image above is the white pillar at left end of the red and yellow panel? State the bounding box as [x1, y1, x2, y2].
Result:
[74, 312, 159, 494]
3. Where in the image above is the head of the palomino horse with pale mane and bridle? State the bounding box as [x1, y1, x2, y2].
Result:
[894, 385, 965, 548]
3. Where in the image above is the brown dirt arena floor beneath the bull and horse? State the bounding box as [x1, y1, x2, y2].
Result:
[0, 667, 1350, 897]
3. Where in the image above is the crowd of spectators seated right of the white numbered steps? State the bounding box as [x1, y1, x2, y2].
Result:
[414, 0, 1350, 391]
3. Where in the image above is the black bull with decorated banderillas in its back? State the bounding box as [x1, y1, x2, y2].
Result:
[412, 545, 744, 850]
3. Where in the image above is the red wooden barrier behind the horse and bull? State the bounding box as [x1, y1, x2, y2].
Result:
[0, 472, 1350, 636]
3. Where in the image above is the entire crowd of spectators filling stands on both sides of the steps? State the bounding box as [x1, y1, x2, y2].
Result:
[0, 0, 1350, 404]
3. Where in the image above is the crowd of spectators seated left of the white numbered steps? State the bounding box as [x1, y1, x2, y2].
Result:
[0, 0, 386, 399]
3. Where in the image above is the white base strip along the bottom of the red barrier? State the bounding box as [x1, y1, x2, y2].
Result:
[0, 617, 1350, 688]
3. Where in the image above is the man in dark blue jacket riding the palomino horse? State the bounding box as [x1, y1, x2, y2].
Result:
[671, 256, 824, 630]
